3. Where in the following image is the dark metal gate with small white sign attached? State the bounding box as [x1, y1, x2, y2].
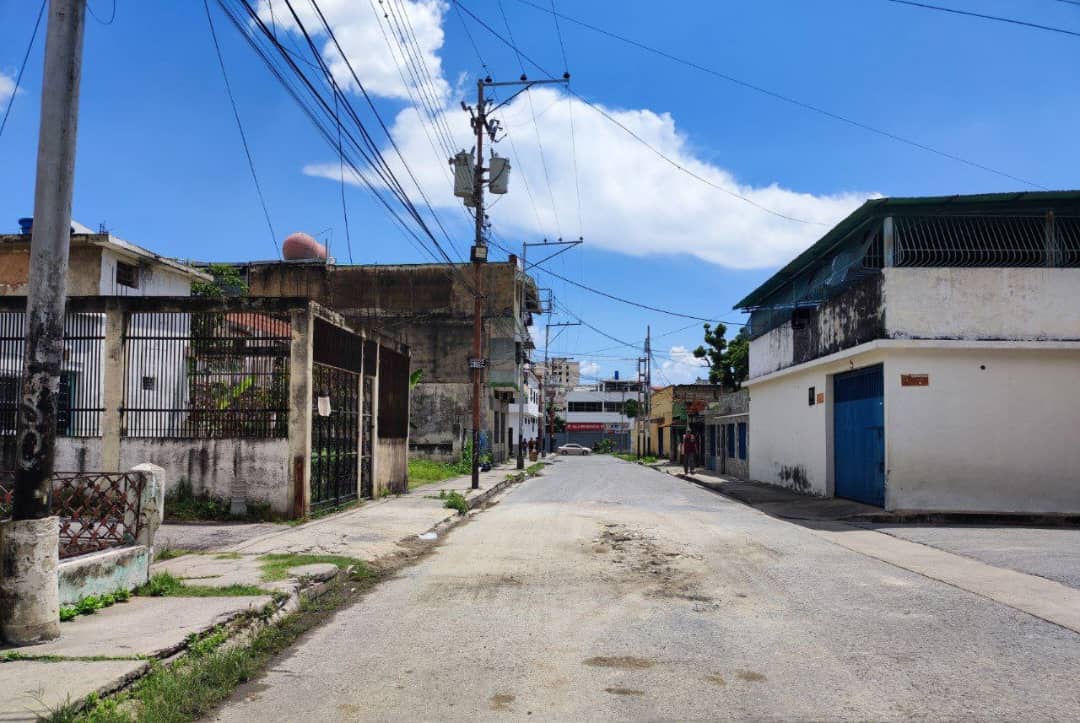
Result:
[311, 363, 360, 509]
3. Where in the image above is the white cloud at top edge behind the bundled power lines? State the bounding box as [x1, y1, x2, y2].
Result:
[257, 0, 449, 106]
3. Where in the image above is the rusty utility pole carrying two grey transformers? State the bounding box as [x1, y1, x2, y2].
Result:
[450, 72, 570, 490]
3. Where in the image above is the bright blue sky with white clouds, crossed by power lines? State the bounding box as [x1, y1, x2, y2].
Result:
[0, 0, 1080, 383]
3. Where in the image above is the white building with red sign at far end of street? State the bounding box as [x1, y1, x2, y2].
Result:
[556, 376, 642, 452]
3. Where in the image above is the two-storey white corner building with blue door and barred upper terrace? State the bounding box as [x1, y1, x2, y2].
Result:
[737, 191, 1080, 513]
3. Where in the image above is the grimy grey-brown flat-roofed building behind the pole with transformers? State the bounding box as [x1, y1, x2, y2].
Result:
[243, 257, 540, 461]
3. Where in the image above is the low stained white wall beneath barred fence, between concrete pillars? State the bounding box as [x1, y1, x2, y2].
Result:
[120, 438, 292, 516]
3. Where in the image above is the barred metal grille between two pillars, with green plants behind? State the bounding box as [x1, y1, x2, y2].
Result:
[122, 311, 292, 439]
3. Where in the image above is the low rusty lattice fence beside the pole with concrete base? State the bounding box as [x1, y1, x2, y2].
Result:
[0, 471, 146, 559]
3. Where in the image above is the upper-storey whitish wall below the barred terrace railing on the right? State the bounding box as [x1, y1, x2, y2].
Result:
[882, 268, 1080, 339]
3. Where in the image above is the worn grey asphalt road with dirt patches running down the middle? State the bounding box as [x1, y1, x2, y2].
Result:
[212, 456, 1080, 721]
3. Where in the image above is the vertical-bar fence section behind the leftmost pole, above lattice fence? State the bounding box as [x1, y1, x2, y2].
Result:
[0, 311, 105, 469]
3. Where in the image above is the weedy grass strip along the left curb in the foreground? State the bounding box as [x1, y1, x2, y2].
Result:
[48, 567, 375, 723]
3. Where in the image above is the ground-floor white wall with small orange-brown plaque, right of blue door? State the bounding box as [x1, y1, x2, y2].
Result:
[881, 345, 1080, 513]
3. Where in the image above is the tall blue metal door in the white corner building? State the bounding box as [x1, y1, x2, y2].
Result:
[833, 364, 885, 507]
